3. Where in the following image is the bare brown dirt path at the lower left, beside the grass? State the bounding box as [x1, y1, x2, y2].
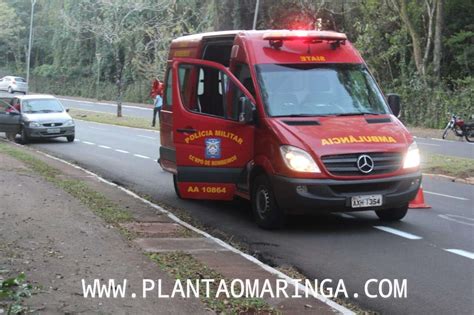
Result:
[0, 146, 208, 314]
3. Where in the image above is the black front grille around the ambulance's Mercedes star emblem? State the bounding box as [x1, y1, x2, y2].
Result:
[322, 152, 403, 176]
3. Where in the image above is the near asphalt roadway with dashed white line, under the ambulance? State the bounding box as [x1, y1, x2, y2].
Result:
[3, 119, 474, 314]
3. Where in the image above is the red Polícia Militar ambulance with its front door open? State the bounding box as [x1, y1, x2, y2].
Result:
[159, 30, 421, 228]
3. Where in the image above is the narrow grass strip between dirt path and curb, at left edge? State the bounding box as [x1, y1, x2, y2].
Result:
[0, 143, 132, 224]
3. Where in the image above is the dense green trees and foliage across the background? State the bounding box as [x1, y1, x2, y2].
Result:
[0, 0, 474, 127]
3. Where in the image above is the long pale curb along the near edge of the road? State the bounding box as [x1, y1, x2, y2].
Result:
[31, 147, 355, 315]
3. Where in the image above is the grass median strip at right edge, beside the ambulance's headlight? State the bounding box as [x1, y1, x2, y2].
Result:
[421, 154, 474, 178]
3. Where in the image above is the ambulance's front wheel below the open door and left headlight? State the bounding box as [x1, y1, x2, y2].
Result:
[251, 175, 285, 230]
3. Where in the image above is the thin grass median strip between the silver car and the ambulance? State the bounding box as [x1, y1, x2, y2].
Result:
[69, 109, 159, 130]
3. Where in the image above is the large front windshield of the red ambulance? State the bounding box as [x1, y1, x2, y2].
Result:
[256, 64, 390, 117]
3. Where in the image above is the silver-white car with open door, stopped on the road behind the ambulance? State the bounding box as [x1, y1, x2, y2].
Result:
[0, 94, 75, 143]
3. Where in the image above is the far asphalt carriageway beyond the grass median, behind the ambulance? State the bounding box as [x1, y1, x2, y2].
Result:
[61, 98, 474, 159]
